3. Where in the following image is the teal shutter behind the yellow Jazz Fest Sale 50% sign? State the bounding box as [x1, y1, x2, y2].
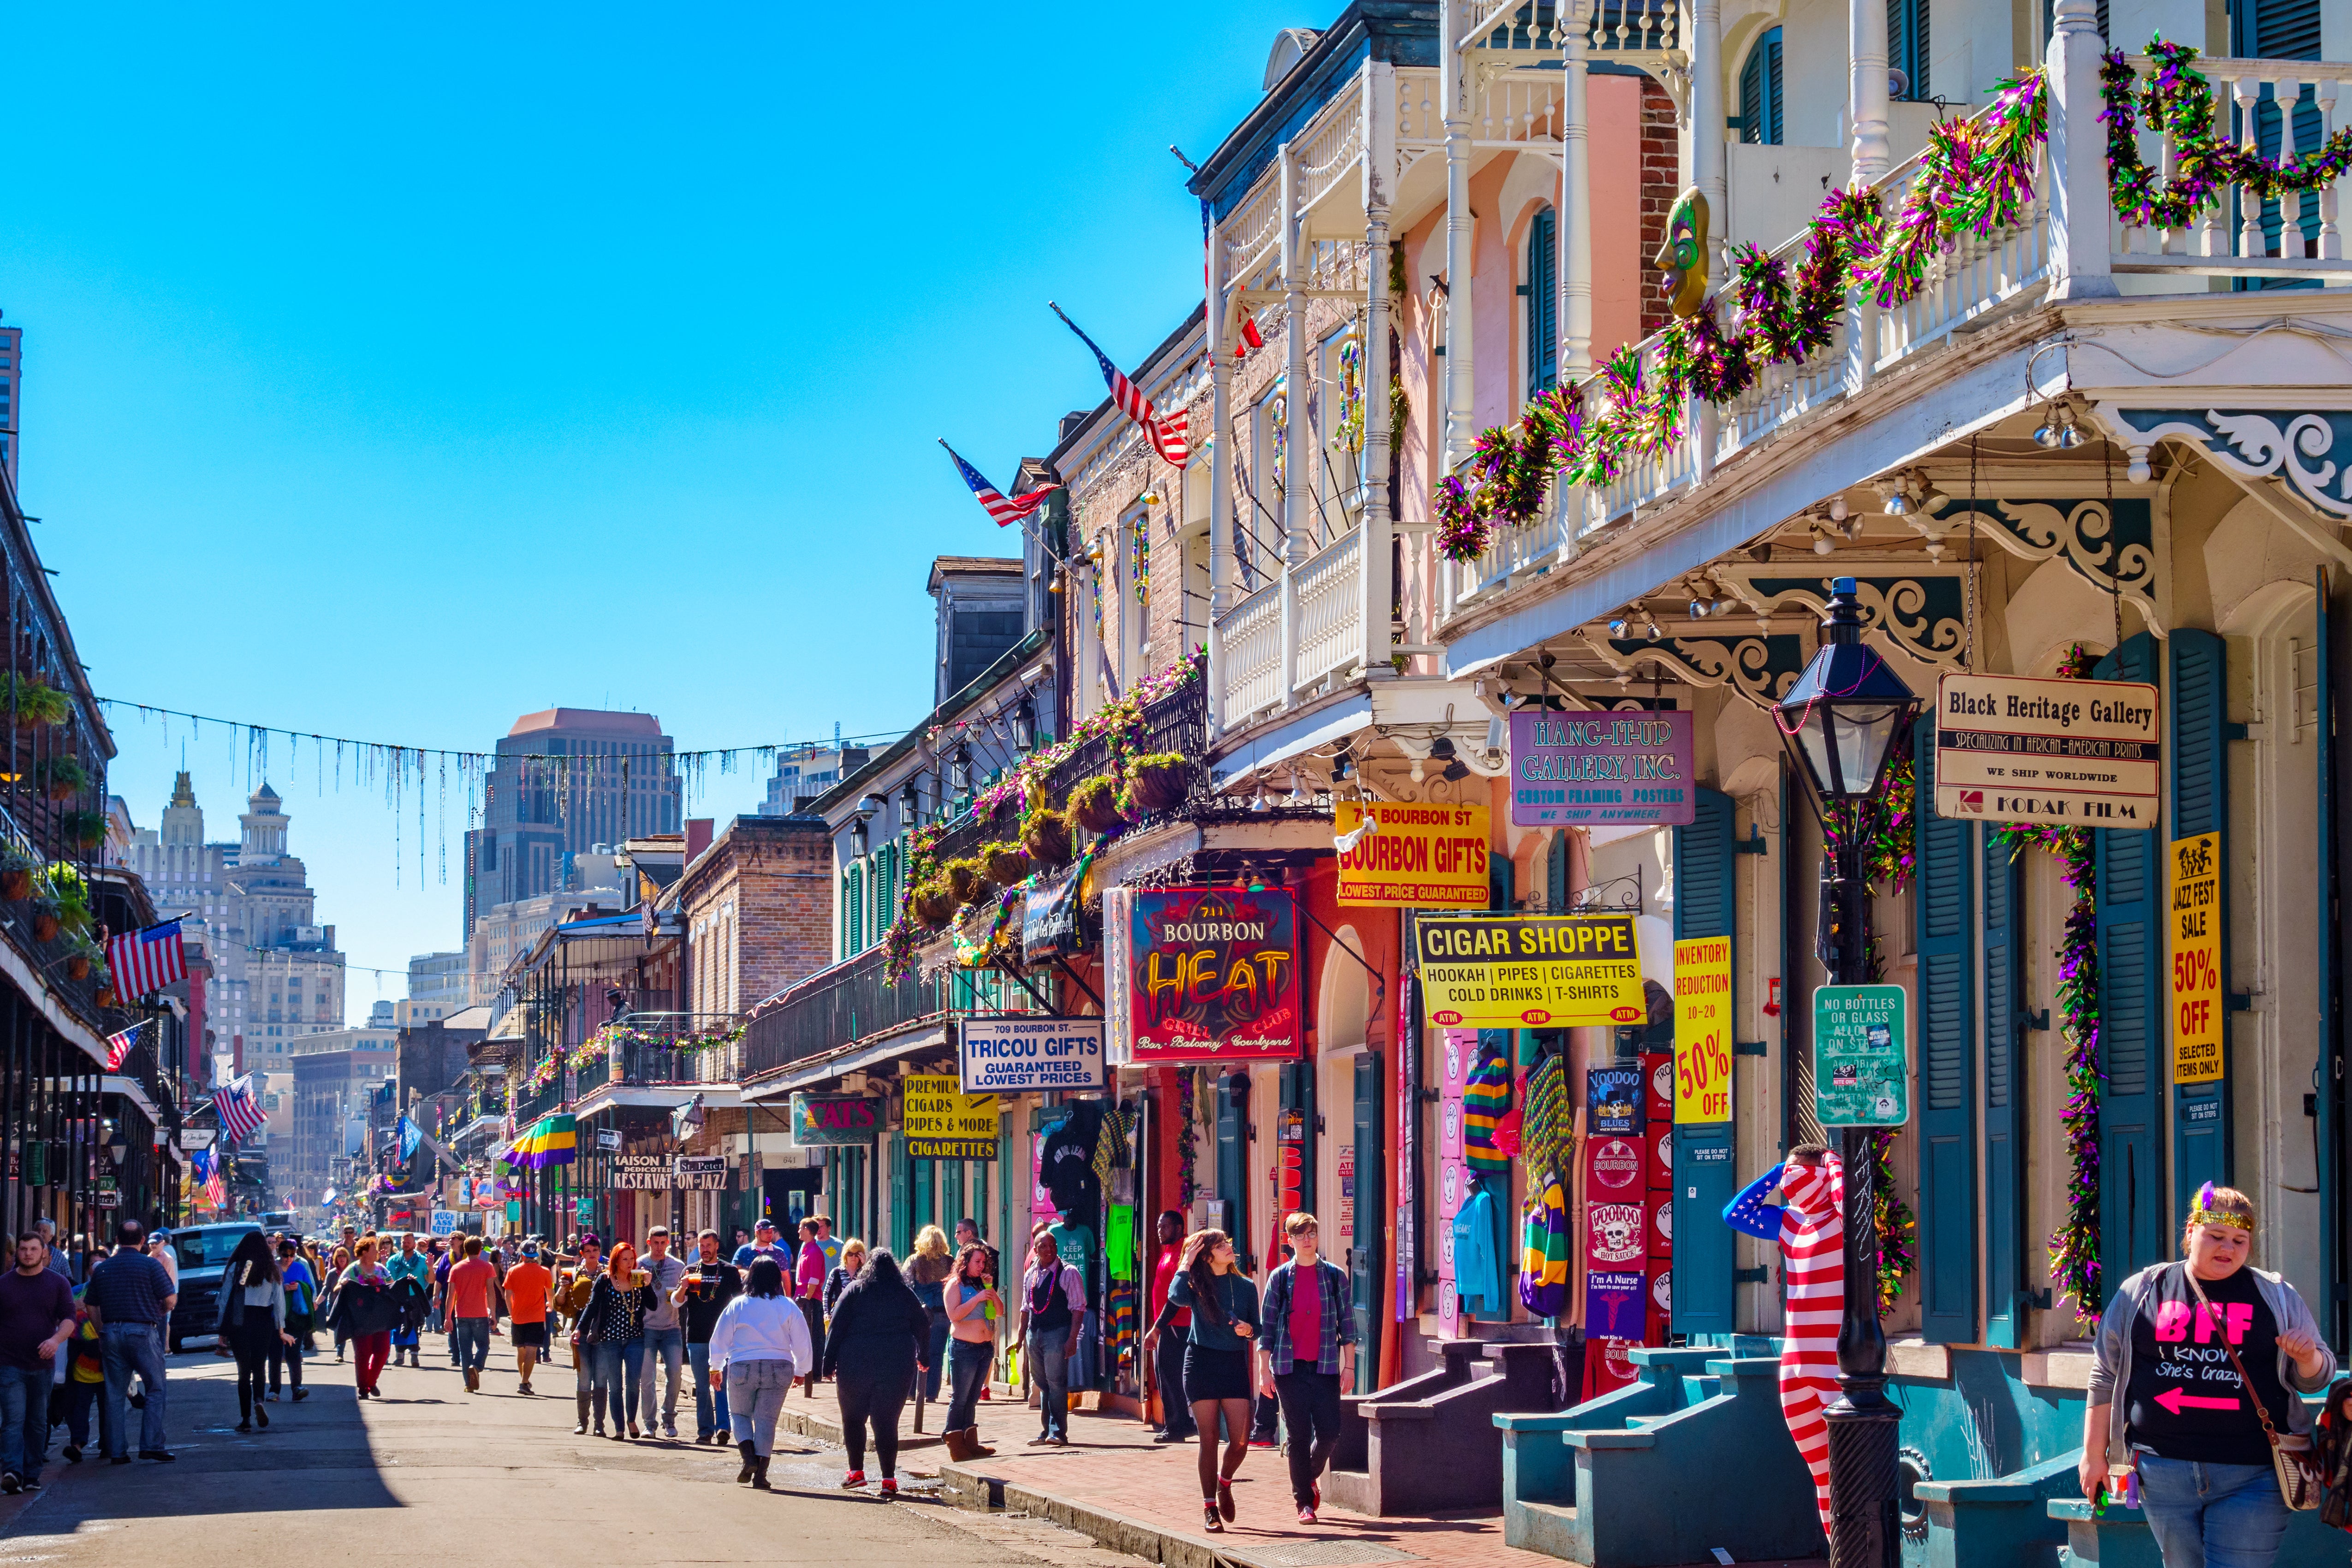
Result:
[2145, 628, 2237, 1215]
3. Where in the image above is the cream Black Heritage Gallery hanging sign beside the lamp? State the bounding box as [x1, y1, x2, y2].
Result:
[1936, 672, 2162, 827]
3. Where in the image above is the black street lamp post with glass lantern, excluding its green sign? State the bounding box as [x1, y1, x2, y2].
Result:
[1773, 578, 1919, 1568]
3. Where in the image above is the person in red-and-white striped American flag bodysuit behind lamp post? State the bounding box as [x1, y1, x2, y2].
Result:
[1724, 1142, 1847, 1535]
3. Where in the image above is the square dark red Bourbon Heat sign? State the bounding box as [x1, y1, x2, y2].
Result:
[1127, 889, 1303, 1063]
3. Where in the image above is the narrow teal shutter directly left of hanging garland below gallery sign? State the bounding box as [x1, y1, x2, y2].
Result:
[1983, 830, 2025, 1349]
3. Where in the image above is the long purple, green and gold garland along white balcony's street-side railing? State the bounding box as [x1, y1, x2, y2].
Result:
[1430, 71, 2049, 562]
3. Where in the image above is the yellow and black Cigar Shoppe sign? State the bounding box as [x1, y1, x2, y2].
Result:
[1414, 915, 1649, 1030]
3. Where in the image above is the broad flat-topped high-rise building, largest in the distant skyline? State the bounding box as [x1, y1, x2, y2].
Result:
[463, 707, 682, 945]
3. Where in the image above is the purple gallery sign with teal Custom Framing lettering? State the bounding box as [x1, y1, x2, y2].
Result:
[1510, 710, 1698, 827]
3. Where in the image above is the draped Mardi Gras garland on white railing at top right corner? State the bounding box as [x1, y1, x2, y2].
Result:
[2098, 33, 2352, 228]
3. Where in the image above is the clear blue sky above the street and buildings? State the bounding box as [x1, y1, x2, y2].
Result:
[0, 0, 1298, 1018]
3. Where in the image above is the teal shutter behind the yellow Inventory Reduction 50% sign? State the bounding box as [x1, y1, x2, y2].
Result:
[1672, 790, 1740, 1345]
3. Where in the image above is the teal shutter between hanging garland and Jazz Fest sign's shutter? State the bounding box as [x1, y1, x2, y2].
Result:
[2086, 632, 2171, 1305]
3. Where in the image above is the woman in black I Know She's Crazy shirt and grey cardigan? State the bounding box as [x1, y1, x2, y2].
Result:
[2079, 1182, 2335, 1568]
